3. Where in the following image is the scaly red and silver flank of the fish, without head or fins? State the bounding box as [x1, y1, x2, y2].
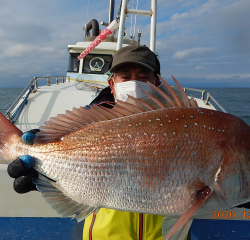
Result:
[15, 108, 229, 214]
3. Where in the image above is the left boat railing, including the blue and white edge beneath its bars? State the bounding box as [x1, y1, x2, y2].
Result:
[5, 76, 70, 123]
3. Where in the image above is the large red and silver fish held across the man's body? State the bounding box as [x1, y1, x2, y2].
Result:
[0, 76, 250, 239]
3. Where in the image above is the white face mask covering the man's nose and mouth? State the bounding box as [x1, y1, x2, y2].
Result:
[114, 80, 150, 102]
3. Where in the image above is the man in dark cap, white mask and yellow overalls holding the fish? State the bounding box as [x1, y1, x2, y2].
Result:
[8, 46, 188, 240]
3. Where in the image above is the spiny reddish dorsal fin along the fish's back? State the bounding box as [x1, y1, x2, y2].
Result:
[34, 76, 198, 143]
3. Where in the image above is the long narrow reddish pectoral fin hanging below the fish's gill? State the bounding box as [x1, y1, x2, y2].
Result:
[163, 187, 212, 240]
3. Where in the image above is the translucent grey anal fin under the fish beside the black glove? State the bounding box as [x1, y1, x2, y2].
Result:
[33, 174, 99, 222]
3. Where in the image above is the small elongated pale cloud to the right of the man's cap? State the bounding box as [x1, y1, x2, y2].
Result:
[172, 47, 215, 60]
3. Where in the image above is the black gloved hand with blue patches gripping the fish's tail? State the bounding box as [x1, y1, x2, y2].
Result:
[7, 129, 40, 193]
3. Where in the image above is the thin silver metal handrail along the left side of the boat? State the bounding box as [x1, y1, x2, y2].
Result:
[5, 76, 70, 119]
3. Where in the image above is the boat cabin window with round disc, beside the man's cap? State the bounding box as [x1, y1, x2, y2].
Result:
[82, 54, 112, 74]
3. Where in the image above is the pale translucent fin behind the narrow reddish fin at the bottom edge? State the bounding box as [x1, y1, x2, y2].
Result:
[162, 216, 193, 240]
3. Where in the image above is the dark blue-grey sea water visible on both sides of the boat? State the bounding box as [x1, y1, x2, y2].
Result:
[0, 88, 250, 125]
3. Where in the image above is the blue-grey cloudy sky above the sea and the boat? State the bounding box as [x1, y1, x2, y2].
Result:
[0, 0, 250, 88]
